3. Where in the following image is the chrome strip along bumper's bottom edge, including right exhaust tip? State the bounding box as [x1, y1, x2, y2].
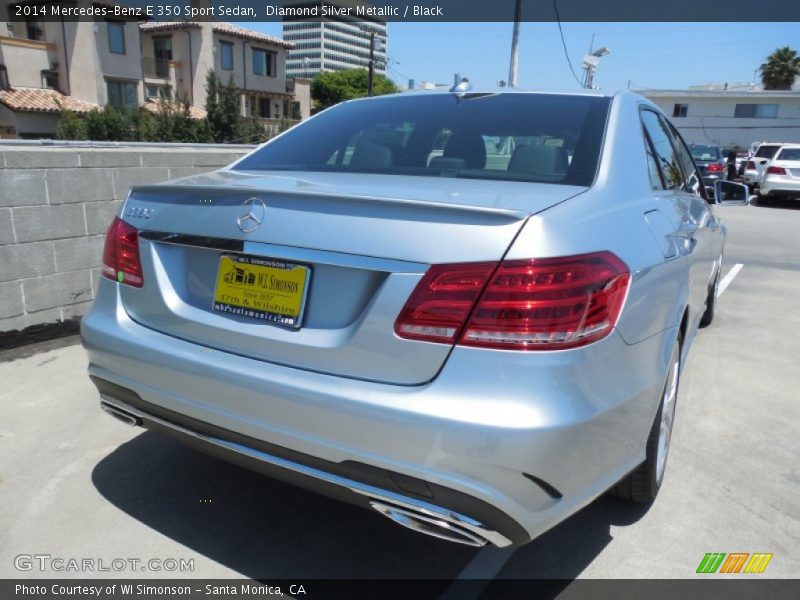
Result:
[100, 394, 512, 548]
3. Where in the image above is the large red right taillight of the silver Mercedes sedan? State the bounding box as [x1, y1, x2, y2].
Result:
[395, 252, 630, 350]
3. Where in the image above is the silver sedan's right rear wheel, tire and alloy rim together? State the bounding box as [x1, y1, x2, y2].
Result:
[612, 336, 681, 504]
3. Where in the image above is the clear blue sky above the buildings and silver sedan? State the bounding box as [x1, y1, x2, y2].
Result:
[250, 21, 800, 90]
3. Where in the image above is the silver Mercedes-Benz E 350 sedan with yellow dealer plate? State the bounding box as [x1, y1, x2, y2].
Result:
[82, 90, 745, 547]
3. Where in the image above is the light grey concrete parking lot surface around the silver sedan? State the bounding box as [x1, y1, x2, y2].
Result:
[0, 202, 800, 579]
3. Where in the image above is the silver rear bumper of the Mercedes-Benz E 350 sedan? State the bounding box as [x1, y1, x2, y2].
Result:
[82, 279, 676, 546]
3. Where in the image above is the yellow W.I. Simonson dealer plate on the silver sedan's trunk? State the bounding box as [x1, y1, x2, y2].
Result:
[214, 254, 310, 328]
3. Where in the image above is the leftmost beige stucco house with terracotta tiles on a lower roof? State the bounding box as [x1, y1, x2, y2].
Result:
[0, 0, 144, 138]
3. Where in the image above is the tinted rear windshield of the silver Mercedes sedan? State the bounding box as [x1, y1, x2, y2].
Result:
[236, 94, 610, 186]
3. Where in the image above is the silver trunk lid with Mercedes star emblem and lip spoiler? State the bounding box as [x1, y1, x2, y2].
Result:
[115, 171, 585, 385]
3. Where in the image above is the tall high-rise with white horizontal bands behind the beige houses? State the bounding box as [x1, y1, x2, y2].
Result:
[283, 0, 388, 77]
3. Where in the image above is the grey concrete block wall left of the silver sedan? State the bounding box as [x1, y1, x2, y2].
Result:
[0, 141, 248, 335]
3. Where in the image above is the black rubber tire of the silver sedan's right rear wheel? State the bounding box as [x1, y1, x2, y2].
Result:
[611, 335, 681, 504]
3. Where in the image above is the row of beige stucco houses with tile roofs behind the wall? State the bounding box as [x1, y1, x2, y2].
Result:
[0, 0, 311, 138]
